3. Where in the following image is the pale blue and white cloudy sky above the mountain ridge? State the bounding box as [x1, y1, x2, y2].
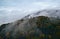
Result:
[0, 0, 60, 24]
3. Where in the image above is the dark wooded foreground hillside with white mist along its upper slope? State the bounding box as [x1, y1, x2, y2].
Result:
[0, 10, 60, 39]
